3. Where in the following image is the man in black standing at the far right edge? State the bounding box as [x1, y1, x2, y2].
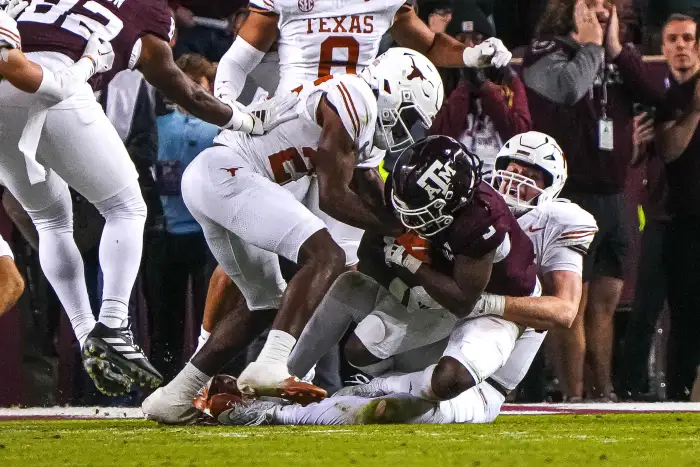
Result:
[657, 15, 700, 400]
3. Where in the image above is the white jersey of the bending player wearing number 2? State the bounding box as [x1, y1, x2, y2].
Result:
[214, 75, 377, 185]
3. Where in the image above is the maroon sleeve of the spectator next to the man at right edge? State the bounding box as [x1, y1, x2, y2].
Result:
[615, 45, 665, 104]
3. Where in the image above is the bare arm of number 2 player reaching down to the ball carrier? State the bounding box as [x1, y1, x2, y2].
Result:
[315, 97, 404, 236]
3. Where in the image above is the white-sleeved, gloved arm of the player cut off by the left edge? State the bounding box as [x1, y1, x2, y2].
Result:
[0, 0, 114, 102]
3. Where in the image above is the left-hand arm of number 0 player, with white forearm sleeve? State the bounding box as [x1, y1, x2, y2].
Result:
[214, 5, 279, 102]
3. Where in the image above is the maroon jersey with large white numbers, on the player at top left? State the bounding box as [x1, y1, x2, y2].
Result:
[17, 0, 174, 90]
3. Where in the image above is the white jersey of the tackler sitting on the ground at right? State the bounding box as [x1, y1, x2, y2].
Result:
[492, 199, 598, 390]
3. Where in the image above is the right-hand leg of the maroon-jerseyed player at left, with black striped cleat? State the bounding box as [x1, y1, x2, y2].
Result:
[42, 106, 162, 387]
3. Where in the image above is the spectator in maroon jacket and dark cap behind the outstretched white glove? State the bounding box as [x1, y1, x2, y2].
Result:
[430, 1, 532, 177]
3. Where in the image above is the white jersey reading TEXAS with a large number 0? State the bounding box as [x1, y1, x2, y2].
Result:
[250, 0, 406, 92]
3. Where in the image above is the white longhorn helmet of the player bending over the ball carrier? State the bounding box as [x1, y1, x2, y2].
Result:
[360, 47, 444, 151]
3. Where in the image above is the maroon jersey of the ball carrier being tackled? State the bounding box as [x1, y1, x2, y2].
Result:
[431, 182, 537, 297]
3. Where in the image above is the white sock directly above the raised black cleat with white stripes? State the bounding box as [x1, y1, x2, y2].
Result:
[95, 183, 146, 327]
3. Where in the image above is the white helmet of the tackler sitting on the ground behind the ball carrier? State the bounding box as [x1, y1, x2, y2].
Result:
[491, 131, 567, 213]
